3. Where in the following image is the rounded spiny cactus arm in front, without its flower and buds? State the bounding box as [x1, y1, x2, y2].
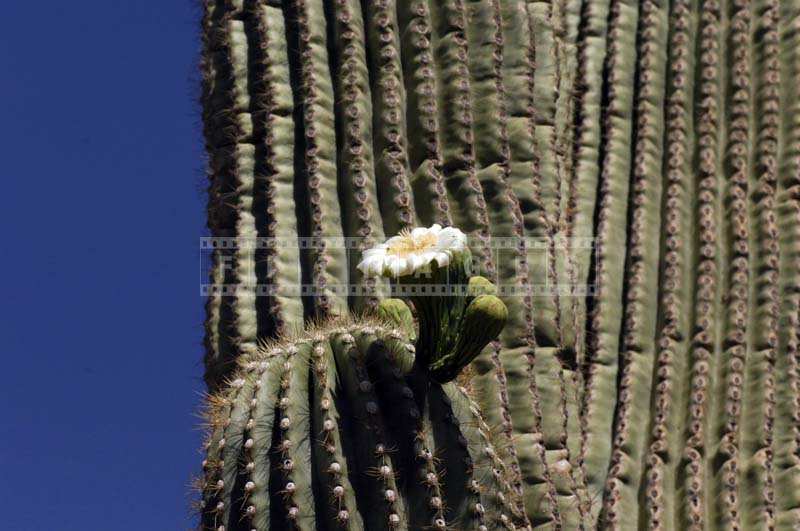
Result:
[202, 318, 523, 531]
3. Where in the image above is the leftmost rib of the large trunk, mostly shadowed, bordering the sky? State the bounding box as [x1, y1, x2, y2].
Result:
[203, 5, 257, 388]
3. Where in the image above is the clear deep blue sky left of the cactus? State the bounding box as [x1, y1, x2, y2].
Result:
[0, 0, 205, 531]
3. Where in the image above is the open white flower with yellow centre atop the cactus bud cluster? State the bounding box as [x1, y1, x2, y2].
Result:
[358, 225, 467, 278]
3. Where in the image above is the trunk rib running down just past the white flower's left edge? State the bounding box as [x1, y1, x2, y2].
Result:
[330, 0, 384, 311]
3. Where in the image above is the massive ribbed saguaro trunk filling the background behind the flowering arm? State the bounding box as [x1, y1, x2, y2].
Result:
[202, 0, 800, 530]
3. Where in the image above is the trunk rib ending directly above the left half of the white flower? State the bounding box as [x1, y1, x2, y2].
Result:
[363, 0, 417, 235]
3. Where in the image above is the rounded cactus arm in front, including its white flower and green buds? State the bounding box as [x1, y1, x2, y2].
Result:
[197, 226, 524, 531]
